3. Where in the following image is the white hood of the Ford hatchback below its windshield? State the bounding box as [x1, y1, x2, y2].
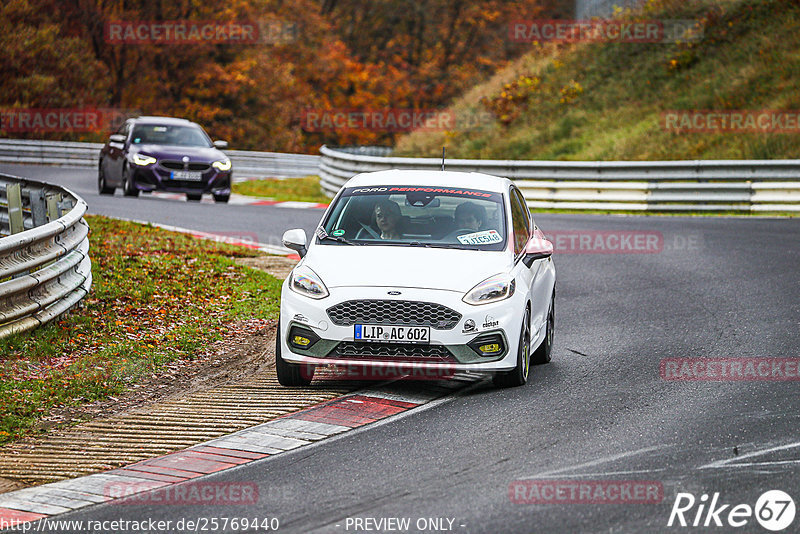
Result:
[303, 244, 513, 293]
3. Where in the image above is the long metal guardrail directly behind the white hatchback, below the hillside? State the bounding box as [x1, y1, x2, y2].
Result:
[319, 146, 800, 212]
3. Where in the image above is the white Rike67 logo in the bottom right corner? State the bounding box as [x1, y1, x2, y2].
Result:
[667, 490, 797, 532]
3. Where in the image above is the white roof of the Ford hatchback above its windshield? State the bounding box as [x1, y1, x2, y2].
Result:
[345, 169, 512, 193]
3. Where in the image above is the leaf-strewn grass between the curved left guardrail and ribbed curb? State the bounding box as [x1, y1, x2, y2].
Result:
[0, 216, 281, 443]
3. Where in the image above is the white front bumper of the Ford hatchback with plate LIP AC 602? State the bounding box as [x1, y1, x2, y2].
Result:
[280, 280, 526, 372]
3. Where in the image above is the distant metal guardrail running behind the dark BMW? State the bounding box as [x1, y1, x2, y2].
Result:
[0, 139, 320, 181]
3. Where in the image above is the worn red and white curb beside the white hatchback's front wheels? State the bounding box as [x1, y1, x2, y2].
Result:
[0, 372, 485, 528]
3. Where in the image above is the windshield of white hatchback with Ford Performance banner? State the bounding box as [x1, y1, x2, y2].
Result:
[317, 186, 506, 250]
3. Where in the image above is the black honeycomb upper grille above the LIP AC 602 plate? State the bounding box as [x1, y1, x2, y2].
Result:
[327, 300, 461, 330]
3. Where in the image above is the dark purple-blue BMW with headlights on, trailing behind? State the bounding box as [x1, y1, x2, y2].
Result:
[97, 117, 232, 202]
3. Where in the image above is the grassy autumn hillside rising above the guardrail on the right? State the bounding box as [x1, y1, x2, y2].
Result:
[396, 0, 800, 160]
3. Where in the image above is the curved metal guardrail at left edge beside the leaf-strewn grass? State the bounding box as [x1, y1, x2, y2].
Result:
[0, 174, 92, 338]
